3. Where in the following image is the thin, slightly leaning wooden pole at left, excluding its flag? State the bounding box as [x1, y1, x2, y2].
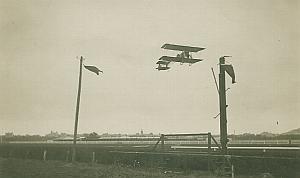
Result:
[72, 56, 83, 162]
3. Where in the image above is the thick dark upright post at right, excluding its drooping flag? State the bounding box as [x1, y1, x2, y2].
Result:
[219, 57, 228, 154]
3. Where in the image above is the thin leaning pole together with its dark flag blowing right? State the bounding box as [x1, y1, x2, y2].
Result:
[72, 56, 103, 162]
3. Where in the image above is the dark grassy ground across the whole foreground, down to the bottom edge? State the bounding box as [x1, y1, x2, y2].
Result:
[0, 144, 300, 178]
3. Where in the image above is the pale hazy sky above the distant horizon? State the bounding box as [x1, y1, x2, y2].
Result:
[0, 0, 300, 134]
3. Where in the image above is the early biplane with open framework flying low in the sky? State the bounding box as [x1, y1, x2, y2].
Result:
[156, 43, 205, 70]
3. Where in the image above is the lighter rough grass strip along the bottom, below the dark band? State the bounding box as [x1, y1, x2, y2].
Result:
[0, 158, 263, 178]
